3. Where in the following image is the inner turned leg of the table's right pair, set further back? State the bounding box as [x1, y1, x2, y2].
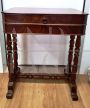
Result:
[66, 35, 75, 77]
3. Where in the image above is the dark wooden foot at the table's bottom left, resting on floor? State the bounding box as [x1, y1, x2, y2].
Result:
[6, 81, 15, 99]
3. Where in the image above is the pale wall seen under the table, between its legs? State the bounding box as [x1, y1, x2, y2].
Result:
[18, 35, 68, 65]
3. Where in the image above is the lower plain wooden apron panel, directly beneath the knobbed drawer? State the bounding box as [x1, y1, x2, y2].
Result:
[5, 24, 85, 35]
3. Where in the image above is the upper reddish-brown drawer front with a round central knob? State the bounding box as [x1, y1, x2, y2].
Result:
[4, 13, 87, 24]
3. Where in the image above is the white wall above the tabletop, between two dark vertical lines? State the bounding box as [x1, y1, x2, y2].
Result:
[3, 0, 84, 10]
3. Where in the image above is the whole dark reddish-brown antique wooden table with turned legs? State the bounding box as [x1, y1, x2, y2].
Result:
[2, 7, 88, 100]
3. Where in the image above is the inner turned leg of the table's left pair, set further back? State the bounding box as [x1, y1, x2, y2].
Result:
[12, 34, 20, 77]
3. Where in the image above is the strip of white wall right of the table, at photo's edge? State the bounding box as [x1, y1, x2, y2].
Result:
[80, 8, 90, 74]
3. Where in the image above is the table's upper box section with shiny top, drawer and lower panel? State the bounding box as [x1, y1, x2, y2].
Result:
[2, 7, 87, 34]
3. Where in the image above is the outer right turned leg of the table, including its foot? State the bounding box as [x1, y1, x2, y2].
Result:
[70, 36, 81, 100]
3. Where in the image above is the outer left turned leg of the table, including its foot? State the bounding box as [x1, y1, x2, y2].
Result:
[6, 34, 15, 99]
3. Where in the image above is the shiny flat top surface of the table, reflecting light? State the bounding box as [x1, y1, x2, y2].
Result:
[3, 7, 86, 14]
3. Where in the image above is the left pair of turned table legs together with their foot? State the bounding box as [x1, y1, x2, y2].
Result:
[6, 34, 20, 99]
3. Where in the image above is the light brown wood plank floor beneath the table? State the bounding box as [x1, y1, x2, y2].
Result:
[0, 74, 90, 108]
